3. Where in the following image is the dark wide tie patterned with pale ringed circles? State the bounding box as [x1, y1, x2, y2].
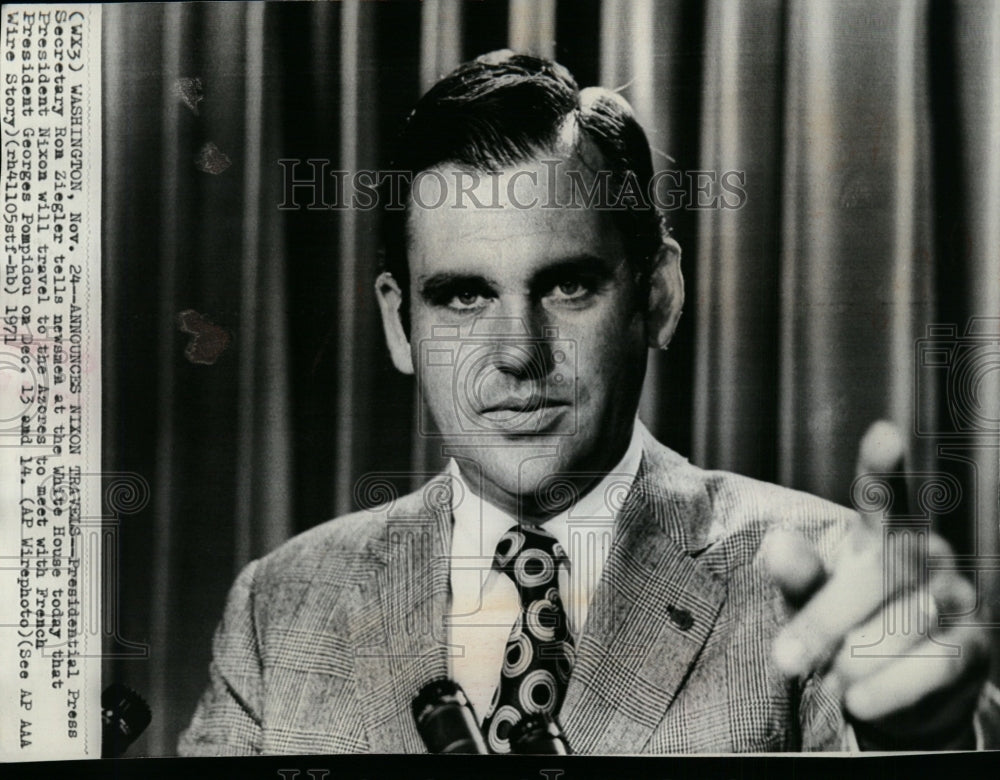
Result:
[483, 525, 574, 753]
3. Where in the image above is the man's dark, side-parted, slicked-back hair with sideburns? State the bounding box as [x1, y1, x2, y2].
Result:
[382, 49, 666, 327]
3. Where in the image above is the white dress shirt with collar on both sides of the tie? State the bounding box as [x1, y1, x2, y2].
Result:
[447, 420, 643, 722]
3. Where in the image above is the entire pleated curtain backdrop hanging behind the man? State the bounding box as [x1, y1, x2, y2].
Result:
[103, 0, 1000, 755]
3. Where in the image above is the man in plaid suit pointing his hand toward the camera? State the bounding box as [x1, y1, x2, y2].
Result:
[181, 52, 996, 754]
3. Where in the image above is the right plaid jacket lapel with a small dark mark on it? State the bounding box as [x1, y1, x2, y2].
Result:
[560, 434, 726, 754]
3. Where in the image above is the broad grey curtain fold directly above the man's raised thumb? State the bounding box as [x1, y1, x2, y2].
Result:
[778, 2, 933, 497]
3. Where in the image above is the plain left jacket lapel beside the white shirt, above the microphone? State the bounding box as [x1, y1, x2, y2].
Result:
[348, 478, 452, 753]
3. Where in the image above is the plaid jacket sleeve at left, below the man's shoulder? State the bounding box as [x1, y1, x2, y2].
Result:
[178, 561, 263, 756]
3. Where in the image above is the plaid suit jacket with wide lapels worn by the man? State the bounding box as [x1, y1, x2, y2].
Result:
[180, 434, 992, 755]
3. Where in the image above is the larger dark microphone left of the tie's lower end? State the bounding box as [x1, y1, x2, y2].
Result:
[413, 678, 489, 755]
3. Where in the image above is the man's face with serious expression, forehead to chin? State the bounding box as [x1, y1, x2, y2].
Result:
[394, 157, 646, 515]
